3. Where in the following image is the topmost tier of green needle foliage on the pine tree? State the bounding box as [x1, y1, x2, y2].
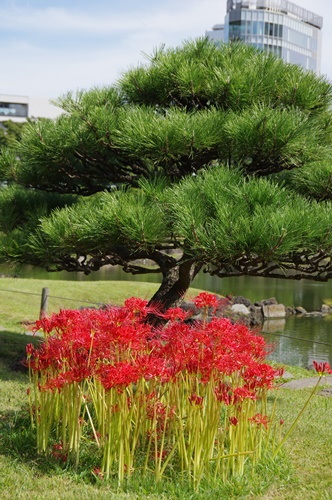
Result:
[120, 39, 331, 113]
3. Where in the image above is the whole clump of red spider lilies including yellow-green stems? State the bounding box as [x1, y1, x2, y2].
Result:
[27, 293, 290, 481]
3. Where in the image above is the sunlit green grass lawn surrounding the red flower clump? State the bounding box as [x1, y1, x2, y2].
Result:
[0, 278, 332, 500]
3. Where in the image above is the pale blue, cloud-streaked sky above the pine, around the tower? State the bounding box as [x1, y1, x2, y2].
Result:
[0, 0, 332, 98]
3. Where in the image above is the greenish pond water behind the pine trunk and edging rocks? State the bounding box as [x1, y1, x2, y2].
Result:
[0, 266, 332, 368]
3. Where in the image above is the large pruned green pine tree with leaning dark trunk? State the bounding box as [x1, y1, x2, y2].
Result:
[0, 39, 332, 309]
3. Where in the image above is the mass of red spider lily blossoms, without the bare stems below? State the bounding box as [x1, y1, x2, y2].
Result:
[27, 293, 276, 405]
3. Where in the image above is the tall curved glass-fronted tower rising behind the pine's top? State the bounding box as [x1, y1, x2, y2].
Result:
[207, 0, 323, 73]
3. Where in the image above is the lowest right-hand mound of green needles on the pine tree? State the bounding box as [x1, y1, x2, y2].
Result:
[167, 167, 332, 263]
